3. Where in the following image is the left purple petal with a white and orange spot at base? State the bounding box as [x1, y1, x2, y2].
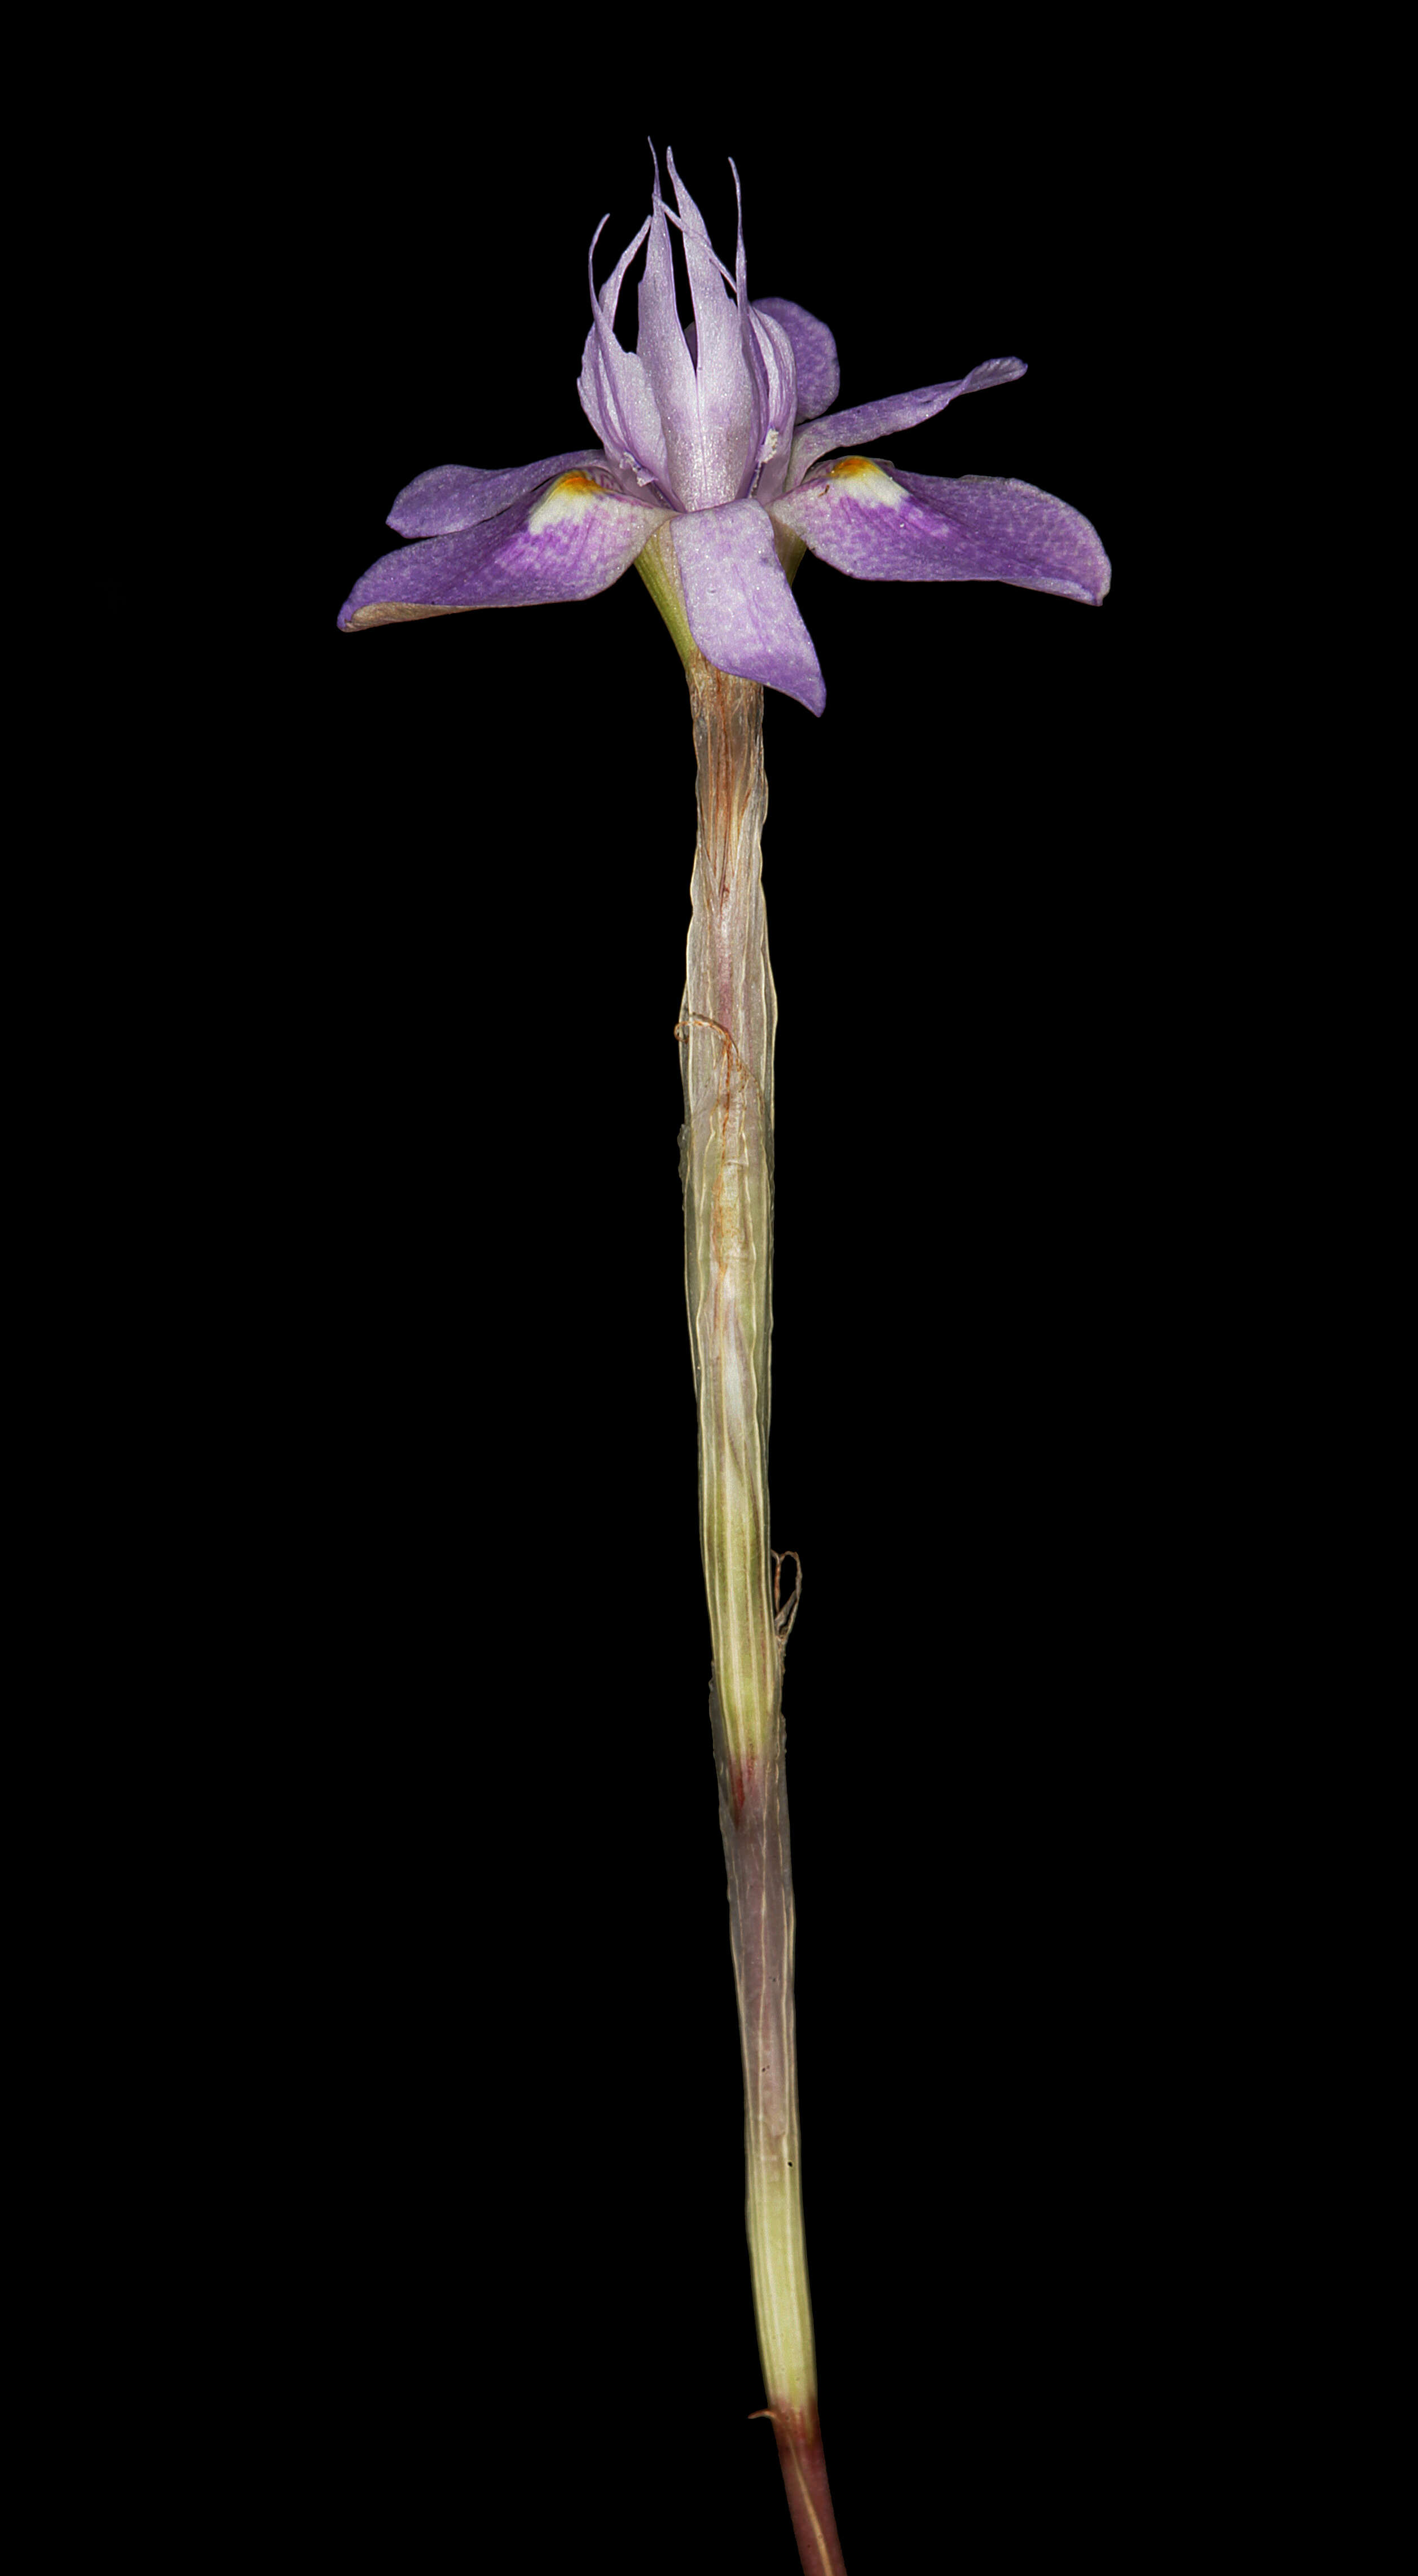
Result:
[337, 469, 679, 634]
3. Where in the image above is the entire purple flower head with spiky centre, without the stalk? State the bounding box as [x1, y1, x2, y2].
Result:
[340, 147, 1109, 716]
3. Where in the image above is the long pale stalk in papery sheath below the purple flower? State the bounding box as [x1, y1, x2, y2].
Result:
[677, 644, 844, 2576]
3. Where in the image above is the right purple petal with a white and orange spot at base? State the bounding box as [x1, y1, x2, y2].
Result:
[772, 456, 1112, 608]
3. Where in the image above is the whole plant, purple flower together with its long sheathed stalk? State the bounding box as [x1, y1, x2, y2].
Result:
[340, 155, 1109, 2576]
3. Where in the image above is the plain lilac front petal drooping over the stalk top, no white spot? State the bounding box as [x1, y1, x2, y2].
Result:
[672, 500, 826, 716]
